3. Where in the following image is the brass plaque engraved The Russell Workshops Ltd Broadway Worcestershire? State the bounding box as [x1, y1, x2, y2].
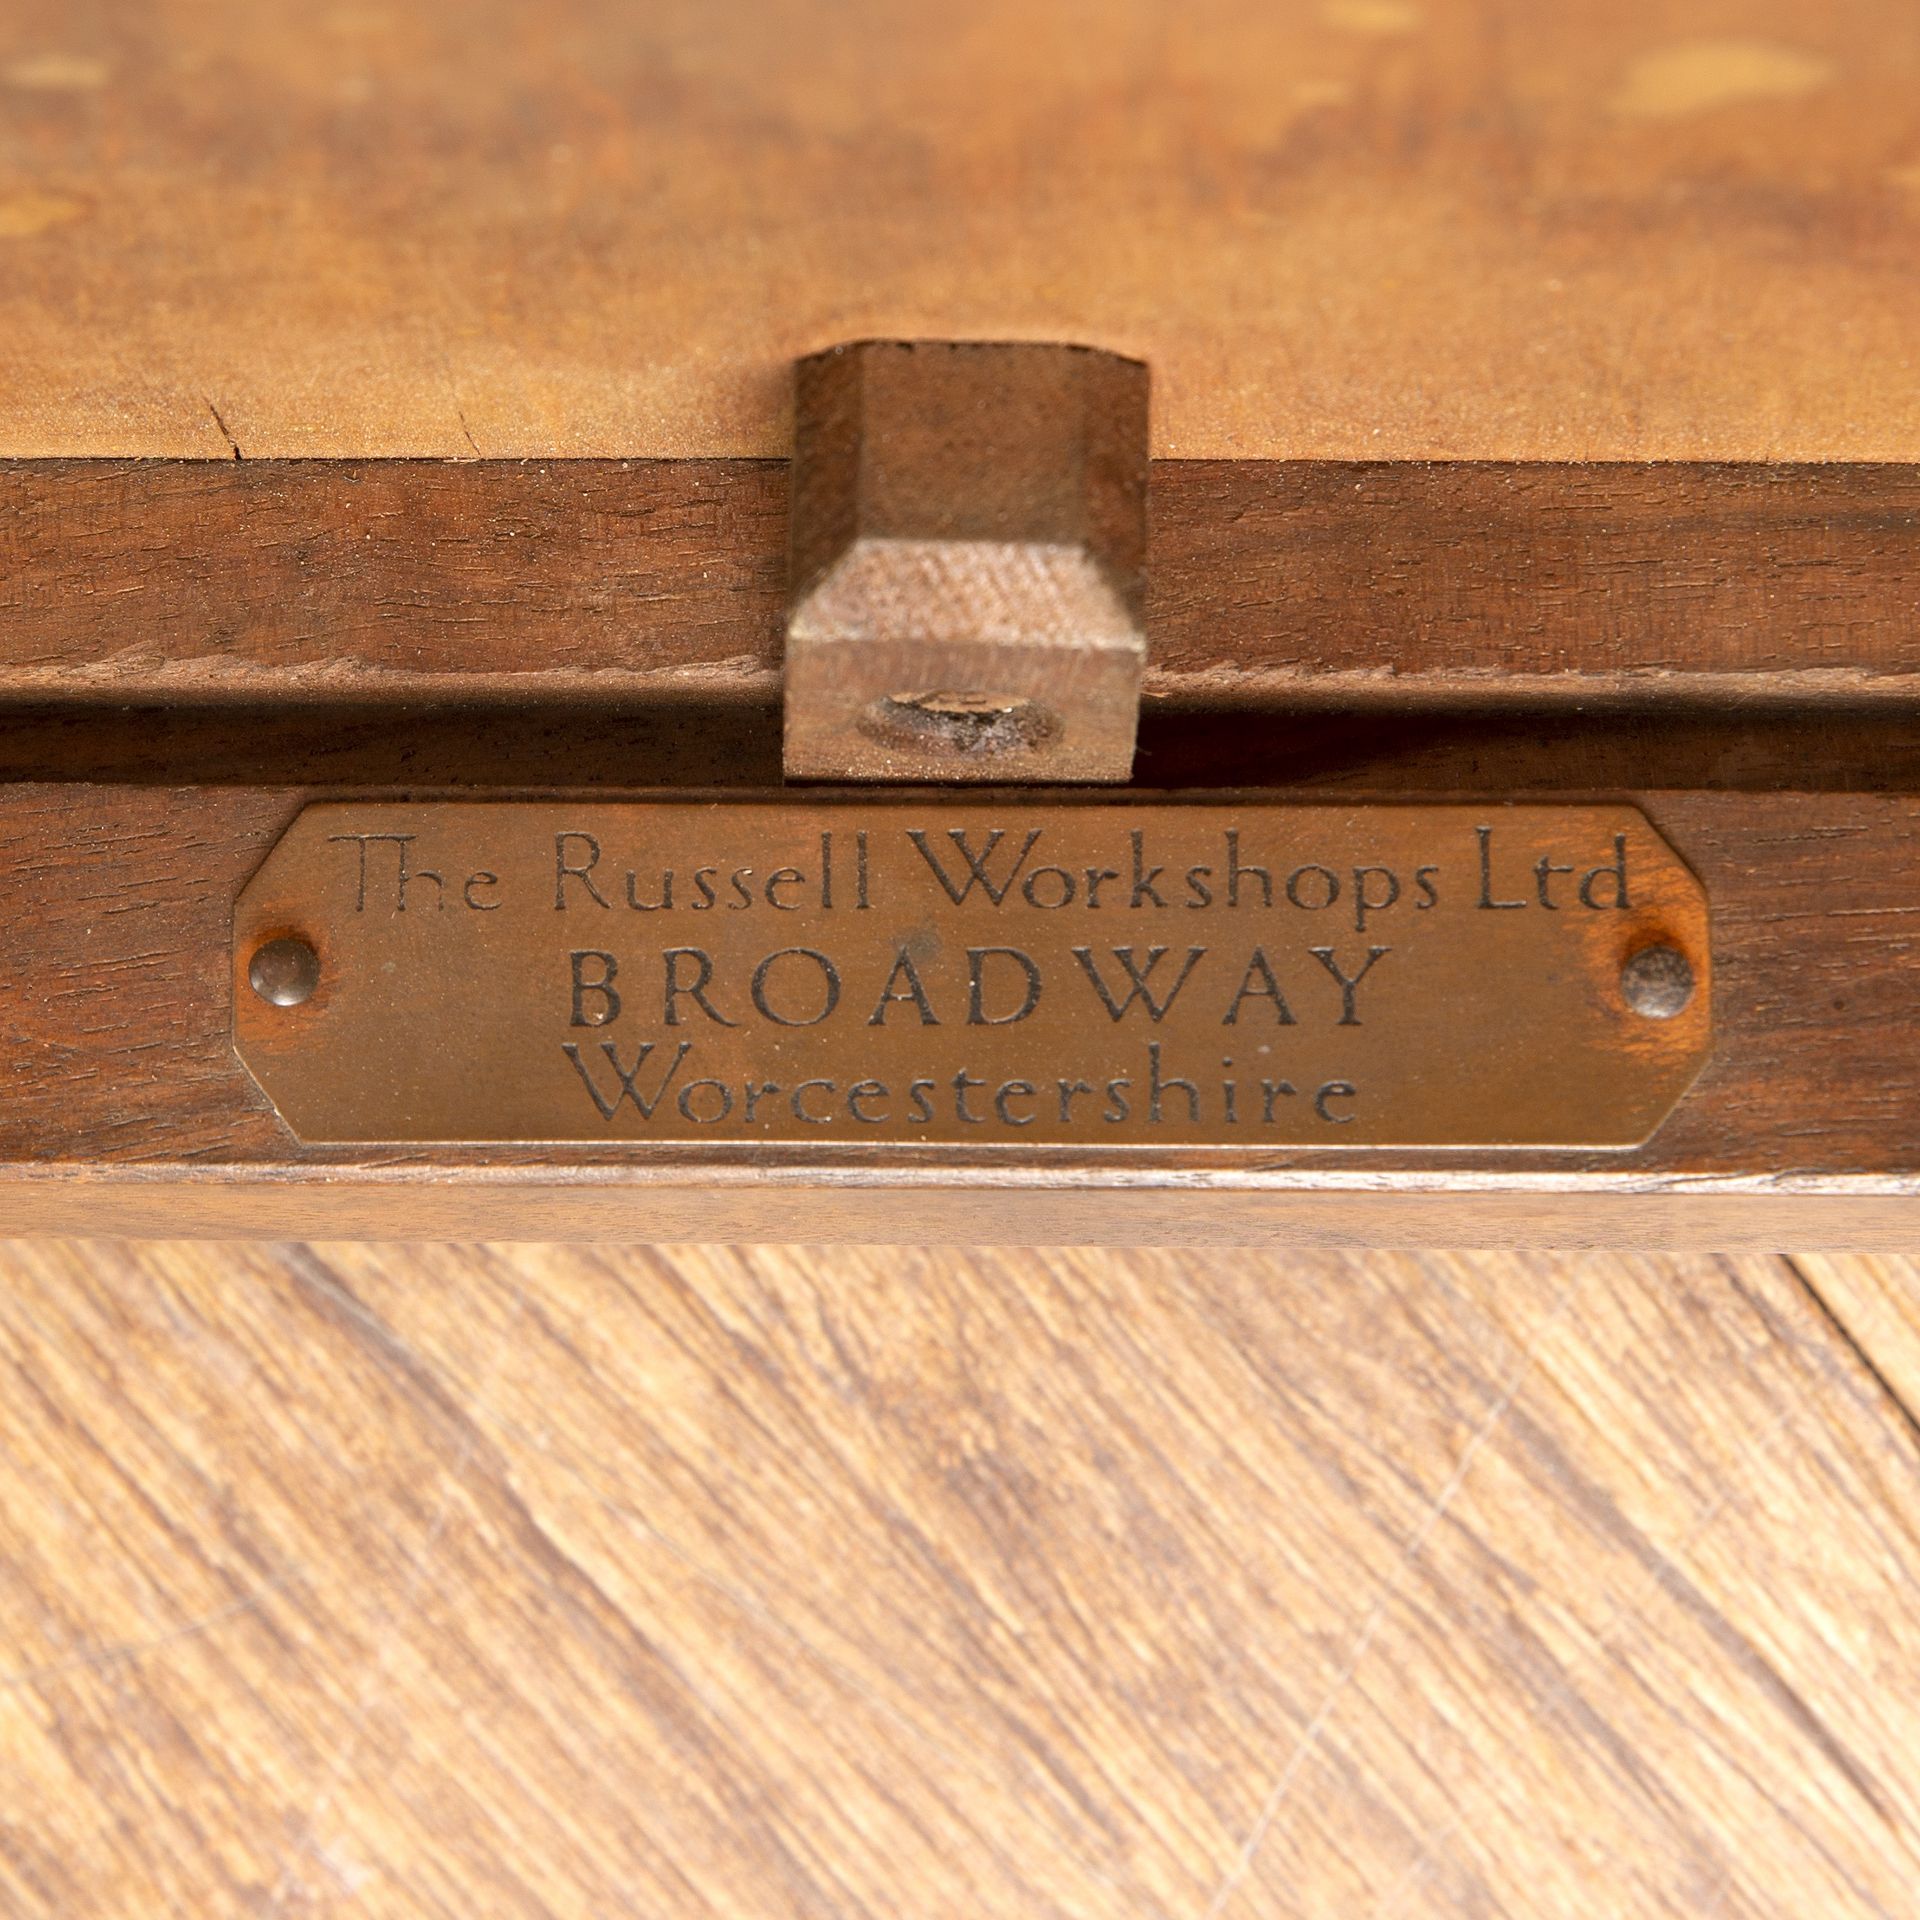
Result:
[232, 797, 1711, 1152]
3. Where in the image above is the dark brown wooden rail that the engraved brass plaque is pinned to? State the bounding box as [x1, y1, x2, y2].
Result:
[0, 785, 1920, 1246]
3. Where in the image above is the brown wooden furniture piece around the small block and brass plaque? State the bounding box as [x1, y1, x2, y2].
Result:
[11, 0, 1920, 1242]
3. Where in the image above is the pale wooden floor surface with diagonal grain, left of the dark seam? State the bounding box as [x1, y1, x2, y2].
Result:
[0, 1244, 1920, 1920]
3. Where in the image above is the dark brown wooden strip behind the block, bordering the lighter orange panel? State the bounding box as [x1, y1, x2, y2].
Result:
[11, 461, 1920, 710]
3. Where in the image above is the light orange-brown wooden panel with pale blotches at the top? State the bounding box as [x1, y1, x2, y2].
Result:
[11, 0, 1920, 459]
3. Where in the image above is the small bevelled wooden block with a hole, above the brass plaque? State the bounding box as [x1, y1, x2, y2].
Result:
[785, 342, 1148, 783]
